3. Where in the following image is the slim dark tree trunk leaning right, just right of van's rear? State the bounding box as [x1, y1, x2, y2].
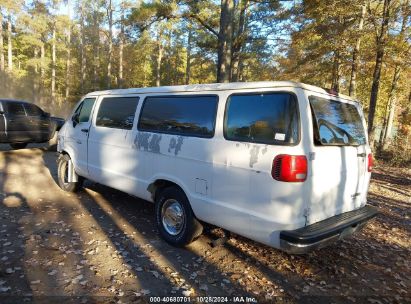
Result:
[368, 0, 391, 148]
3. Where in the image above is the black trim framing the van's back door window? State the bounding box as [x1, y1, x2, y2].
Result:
[307, 95, 368, 147]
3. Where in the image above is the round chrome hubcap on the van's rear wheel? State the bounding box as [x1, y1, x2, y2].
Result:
[161, 199, 184, 235]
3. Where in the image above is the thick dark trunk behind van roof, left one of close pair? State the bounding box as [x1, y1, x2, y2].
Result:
[217, 0, 234, 82]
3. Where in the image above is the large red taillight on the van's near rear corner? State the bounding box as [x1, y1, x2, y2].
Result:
[271, 154, 307, 182]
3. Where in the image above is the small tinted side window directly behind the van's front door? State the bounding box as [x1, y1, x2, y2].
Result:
[96, 97, 139, 130]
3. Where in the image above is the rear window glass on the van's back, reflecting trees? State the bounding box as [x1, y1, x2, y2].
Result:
[309, 96, 366, 146]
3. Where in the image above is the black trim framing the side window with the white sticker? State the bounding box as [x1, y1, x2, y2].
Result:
[223, 91, 301, 147]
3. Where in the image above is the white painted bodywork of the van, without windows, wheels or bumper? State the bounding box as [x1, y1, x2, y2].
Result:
[58, 82, 376, 253]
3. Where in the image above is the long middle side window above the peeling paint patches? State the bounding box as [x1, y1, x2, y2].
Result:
[138, 95, 218, 138]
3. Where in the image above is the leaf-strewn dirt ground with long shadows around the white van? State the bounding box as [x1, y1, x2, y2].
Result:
[0, 145, 411, 303]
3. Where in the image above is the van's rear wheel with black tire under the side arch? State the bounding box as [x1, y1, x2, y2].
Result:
[155, 187, 203, 247]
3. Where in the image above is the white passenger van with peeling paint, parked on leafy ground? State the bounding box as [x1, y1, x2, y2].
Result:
[58, 82, 377, 253]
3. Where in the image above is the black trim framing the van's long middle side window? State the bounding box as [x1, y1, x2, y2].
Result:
[137, 94, 220, 138]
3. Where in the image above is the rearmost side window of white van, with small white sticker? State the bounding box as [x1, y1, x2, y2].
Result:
[224, 92, 299, 145]
